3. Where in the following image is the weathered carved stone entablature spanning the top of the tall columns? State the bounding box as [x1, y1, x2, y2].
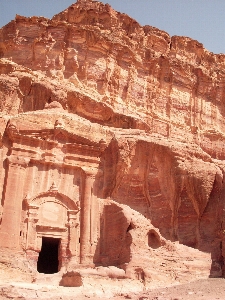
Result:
[8, 124, 107, 168]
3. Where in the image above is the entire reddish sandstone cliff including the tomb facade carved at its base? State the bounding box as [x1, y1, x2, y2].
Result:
[0, 1, 225, 294]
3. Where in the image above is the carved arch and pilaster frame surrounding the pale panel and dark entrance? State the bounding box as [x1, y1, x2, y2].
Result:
[23, 189, 80, 269]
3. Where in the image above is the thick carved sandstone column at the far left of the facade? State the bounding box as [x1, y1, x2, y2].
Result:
[0, 155, 29, 249]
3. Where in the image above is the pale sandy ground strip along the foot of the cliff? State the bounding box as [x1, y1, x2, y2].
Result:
[0, 278, 225, 300]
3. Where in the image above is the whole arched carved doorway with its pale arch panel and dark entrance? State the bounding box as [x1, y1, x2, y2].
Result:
[21, 188, 80, 274]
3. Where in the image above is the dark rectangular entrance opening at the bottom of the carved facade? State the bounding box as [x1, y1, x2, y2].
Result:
[37, 237, 60, 274]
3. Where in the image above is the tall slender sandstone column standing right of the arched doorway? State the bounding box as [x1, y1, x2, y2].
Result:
[80, 172, 95, 264]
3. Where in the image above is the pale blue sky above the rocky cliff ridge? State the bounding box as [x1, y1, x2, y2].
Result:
[0, 0, 225, 53]
